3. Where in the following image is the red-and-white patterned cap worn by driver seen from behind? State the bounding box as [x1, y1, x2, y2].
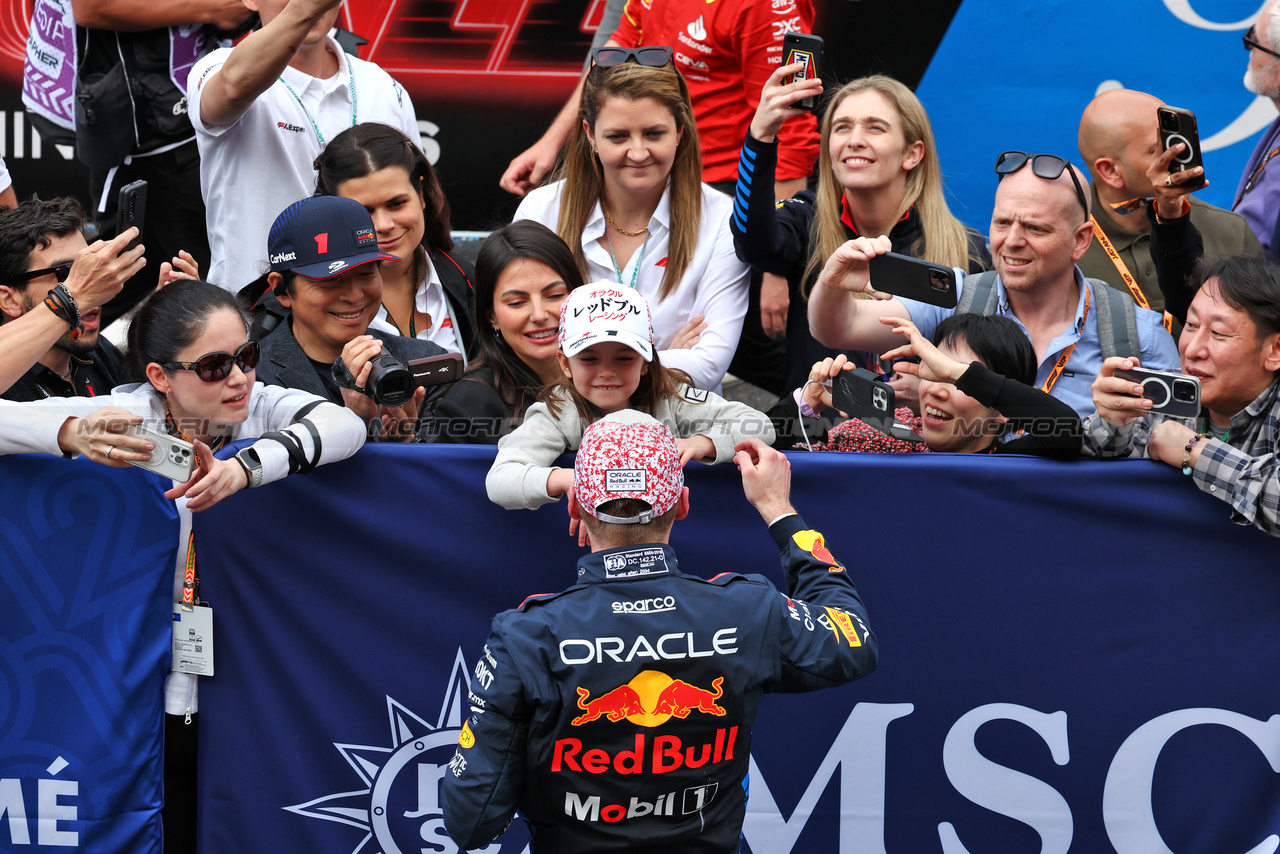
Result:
[573, 410, 685, 525]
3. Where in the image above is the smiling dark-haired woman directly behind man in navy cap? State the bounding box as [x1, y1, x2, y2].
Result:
[315, 122, 475, 360]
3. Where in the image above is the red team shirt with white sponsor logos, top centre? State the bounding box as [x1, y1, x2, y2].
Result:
[613, 0, 818, 184]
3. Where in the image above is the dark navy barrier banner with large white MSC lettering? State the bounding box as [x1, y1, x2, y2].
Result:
[196, 447, 1280, 854]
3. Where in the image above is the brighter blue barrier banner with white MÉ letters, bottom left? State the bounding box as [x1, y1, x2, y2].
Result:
[0, 456, 178, 854]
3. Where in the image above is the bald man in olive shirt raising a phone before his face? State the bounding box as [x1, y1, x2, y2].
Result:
[1079, 88, 1262, 335]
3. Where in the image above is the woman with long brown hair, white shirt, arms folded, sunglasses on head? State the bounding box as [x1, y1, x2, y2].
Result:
[516, 47, 747, 391]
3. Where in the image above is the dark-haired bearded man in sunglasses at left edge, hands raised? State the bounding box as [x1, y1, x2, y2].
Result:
[0, 198, 146, 401]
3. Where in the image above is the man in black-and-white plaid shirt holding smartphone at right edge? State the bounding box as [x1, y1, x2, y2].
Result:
[1084, 255, 1280, 536]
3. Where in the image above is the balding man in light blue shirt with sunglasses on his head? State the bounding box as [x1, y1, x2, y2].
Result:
[809, 151, 1178, 417]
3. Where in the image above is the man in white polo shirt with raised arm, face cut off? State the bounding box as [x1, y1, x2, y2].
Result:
[187, 0, 419, 291]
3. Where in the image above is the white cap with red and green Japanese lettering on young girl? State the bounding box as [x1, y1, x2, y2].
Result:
[561, 282, 653, 362]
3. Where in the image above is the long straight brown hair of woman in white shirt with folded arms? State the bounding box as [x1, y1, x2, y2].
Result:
[556, 63, 703, 301]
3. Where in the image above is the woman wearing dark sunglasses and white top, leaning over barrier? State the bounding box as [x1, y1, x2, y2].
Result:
[0, 279, 365, 850]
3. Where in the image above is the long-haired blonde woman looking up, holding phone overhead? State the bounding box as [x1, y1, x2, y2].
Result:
[730, 63, 991, 407]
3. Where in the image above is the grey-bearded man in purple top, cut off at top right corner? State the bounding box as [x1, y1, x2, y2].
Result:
[1231, 0, 1280, 259]
